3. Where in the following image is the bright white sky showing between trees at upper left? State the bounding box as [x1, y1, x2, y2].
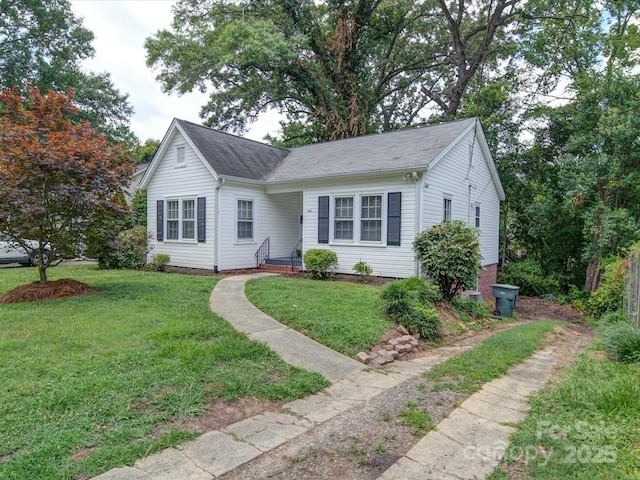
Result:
[71, 0, 279, 141]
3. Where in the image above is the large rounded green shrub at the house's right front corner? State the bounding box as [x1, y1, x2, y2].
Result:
[413, 220, 482, 300]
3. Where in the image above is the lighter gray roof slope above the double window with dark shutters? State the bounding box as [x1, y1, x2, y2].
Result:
[268, 118, 476, 182]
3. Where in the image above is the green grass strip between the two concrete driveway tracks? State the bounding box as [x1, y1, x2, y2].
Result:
[425, 320, 562, 394]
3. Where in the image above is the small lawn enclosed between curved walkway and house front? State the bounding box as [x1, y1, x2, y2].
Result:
[245, 277, 393, 356]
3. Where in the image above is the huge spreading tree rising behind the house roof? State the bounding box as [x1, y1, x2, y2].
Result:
[146, 0, 525, 142]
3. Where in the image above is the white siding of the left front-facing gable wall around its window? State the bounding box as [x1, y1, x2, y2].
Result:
[147, 131, 217, 270]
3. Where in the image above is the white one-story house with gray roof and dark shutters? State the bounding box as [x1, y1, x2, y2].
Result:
[140, 119, 504, 296]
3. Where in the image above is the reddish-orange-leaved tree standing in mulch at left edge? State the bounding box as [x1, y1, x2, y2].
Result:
[0, 88, 133, 284]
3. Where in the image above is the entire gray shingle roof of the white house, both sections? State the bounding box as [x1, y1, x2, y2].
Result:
[176, 118, 476, 182]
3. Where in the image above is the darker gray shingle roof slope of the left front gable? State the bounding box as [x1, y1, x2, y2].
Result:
[176, 119, 289, 180]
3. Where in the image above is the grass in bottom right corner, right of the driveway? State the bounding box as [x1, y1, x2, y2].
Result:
[487, 353, 640, 480]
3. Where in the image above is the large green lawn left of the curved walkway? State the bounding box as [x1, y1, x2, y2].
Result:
[0, 266, 328, 479]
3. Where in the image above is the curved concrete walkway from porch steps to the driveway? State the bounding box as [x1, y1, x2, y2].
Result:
[209, 273, 364, 383]
